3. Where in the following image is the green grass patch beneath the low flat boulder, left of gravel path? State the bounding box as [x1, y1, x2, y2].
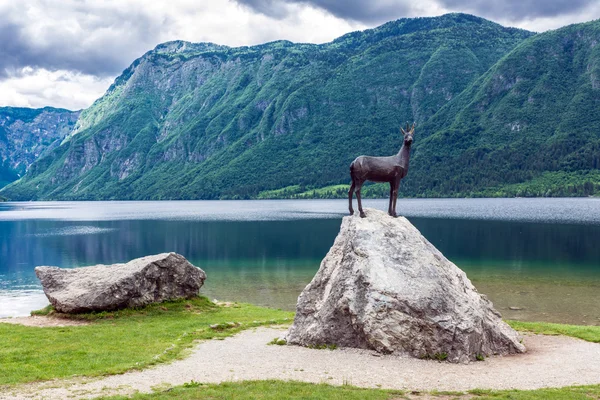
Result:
[0, 297, 293, 385]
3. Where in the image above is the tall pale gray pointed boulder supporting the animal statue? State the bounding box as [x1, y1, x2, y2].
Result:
[286, 209, 525, 362]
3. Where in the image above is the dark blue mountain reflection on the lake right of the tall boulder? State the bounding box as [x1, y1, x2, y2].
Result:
[411, 218, 600, 279]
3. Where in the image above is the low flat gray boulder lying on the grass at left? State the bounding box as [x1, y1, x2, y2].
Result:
[35, 253, 206, 313]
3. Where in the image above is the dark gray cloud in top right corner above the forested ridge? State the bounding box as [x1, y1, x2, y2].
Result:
[438, 0, 597, 21]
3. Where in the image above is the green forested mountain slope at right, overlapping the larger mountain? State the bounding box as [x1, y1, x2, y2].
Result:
[407, 21, 600, 196]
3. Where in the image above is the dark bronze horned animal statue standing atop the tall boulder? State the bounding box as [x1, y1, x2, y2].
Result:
[348, 123, 415, 218]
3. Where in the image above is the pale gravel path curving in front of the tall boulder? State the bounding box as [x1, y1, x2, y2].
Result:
[0, 328, 600, 399]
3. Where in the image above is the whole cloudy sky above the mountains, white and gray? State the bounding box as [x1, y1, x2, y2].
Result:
[0, 0, 600, 110]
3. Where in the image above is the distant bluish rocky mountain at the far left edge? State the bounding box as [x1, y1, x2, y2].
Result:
[0, 107, 79, 187]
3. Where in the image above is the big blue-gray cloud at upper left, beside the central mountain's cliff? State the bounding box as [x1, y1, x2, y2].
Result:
[0, 5, 160, 79]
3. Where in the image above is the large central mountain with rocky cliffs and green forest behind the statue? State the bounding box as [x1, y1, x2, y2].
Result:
[1, 14, 533, 200]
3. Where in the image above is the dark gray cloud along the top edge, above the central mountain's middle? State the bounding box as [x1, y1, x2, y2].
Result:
[235, 0, 411, 24]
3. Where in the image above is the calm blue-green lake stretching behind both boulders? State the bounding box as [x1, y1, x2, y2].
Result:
[0, 198, 600, 325]
